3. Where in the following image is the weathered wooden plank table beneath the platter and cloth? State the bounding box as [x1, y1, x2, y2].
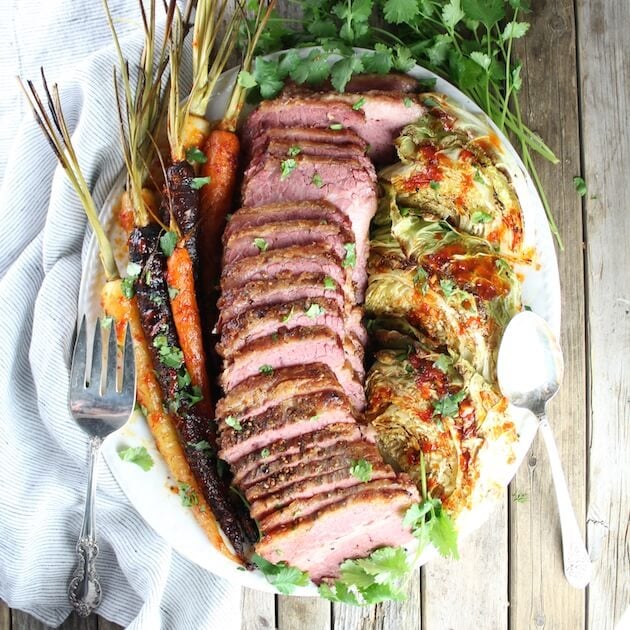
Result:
[0, 0, 630, 630]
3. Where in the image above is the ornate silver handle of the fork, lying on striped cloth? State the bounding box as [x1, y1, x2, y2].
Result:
[68, 437, 102, 617]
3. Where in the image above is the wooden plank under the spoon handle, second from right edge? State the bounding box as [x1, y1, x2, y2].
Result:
[510, 0, 586, 630]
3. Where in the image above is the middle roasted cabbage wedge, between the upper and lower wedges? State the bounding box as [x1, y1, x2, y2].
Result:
[365, 187, 521, 383]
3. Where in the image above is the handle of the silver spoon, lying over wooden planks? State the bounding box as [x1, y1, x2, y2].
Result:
[538, 413, 592, 588]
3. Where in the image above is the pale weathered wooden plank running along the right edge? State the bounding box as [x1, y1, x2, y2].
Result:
[577, 0, 630, 630]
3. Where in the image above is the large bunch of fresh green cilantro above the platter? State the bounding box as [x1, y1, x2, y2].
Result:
[246, 0, 562, 247]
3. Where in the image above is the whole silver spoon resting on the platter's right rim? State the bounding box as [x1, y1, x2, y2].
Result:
[497, 311, 592, 588]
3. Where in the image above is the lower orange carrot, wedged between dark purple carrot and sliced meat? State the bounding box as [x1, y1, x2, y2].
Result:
[166, 244, 212, 418]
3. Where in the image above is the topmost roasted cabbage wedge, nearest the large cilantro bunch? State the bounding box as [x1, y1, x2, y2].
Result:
[379, 93, 524, 260]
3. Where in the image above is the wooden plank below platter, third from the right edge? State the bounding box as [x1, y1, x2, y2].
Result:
[422, 500, 508, 630]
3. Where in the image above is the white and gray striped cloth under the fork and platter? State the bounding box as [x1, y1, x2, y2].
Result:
[0, 0, 240, 630]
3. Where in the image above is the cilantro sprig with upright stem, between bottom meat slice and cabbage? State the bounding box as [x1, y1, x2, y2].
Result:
[403, 453, 459, 560]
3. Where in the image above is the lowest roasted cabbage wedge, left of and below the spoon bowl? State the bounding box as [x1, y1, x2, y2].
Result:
[367, 330, 516, 517]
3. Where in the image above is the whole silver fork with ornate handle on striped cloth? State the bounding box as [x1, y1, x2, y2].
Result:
[68, 318, 136, 617]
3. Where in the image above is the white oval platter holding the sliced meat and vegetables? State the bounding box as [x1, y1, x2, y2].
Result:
[79, 49, 560, 596]
